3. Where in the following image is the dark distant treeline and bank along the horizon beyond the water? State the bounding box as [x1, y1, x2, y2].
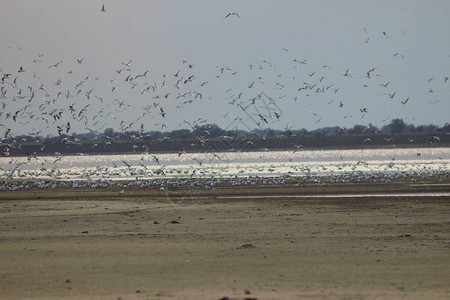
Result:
[0, 119, 450, 156]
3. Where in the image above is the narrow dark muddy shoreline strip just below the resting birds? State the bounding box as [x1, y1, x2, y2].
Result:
[0, 178, 450, 200]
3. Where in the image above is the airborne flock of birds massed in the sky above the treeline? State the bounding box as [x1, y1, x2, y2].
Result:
[0, 41, 448, 143]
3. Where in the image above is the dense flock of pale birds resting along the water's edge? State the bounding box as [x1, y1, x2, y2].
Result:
[0, 165, 450, 193]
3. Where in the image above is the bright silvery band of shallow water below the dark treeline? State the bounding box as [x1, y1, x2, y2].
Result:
[0, 148, 450, 180]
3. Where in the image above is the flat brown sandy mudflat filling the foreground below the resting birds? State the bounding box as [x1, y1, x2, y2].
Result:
[0, 184, 450, 299]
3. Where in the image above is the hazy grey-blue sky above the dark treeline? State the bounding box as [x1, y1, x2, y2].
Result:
[0, 0, 450, 137]
